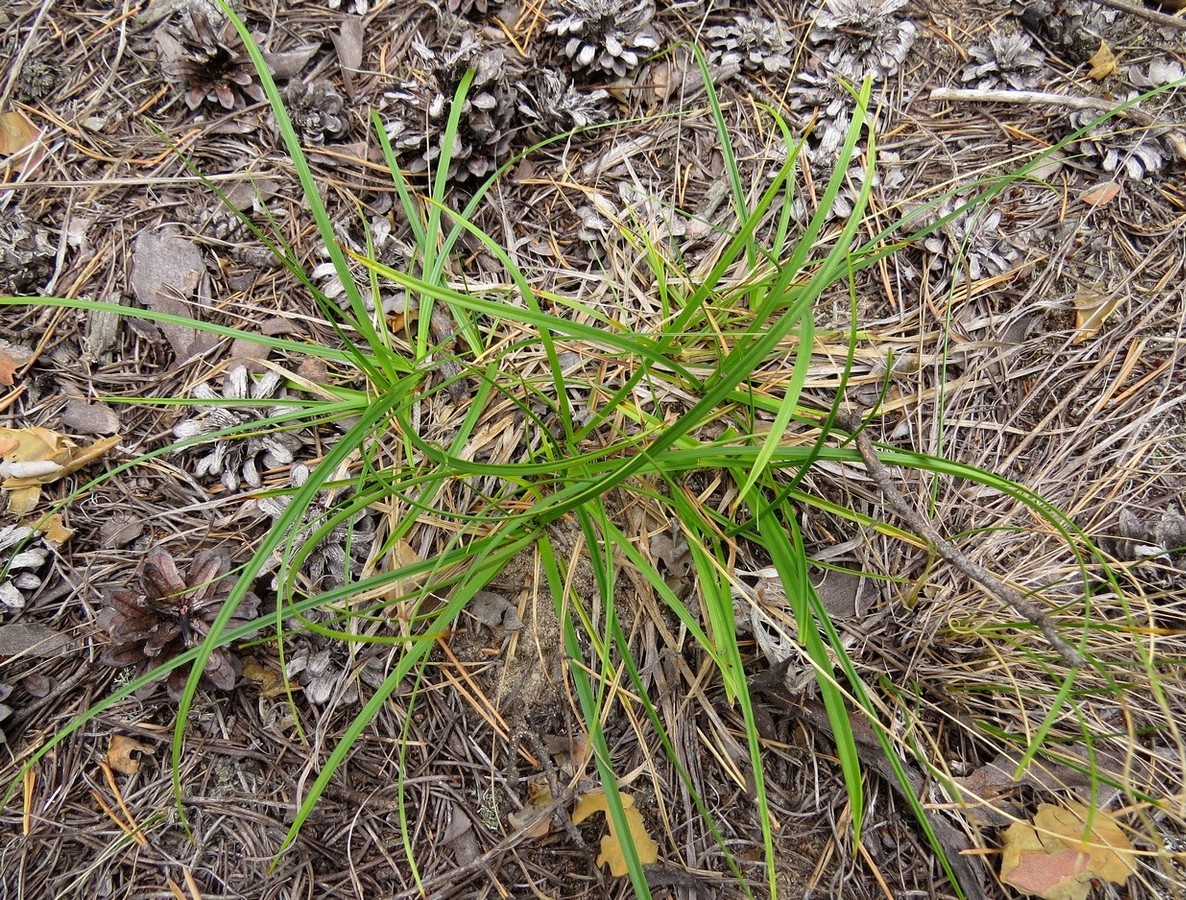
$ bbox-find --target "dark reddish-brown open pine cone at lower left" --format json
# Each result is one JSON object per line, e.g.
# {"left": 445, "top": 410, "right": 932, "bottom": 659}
{"left": 97, "top": 547, "right": 260, "bottom": 701}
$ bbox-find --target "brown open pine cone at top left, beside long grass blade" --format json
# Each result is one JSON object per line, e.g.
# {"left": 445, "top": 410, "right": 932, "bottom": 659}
{"left": 158, "top": 6, "right": 264, "bottom": 109}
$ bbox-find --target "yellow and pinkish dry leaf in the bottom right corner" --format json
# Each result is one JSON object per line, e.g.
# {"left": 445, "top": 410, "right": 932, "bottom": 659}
{"left": 1001, "top": 803, "right": 1134, "bottom": 900}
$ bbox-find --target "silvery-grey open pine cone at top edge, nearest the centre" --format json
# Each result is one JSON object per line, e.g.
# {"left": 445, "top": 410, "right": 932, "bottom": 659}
{"left": 547, "top": 0, "right": 661, "bottom": 78}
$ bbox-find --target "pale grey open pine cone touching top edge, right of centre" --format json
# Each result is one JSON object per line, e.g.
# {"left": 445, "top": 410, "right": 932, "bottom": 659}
{"left": 808, "top": 0, "right": 917, "bottom": 83}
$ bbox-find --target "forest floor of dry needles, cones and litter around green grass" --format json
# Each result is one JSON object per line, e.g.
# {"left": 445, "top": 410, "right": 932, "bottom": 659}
{"left": 0, "top": 0, "right": 1186, "bottom": 899}
